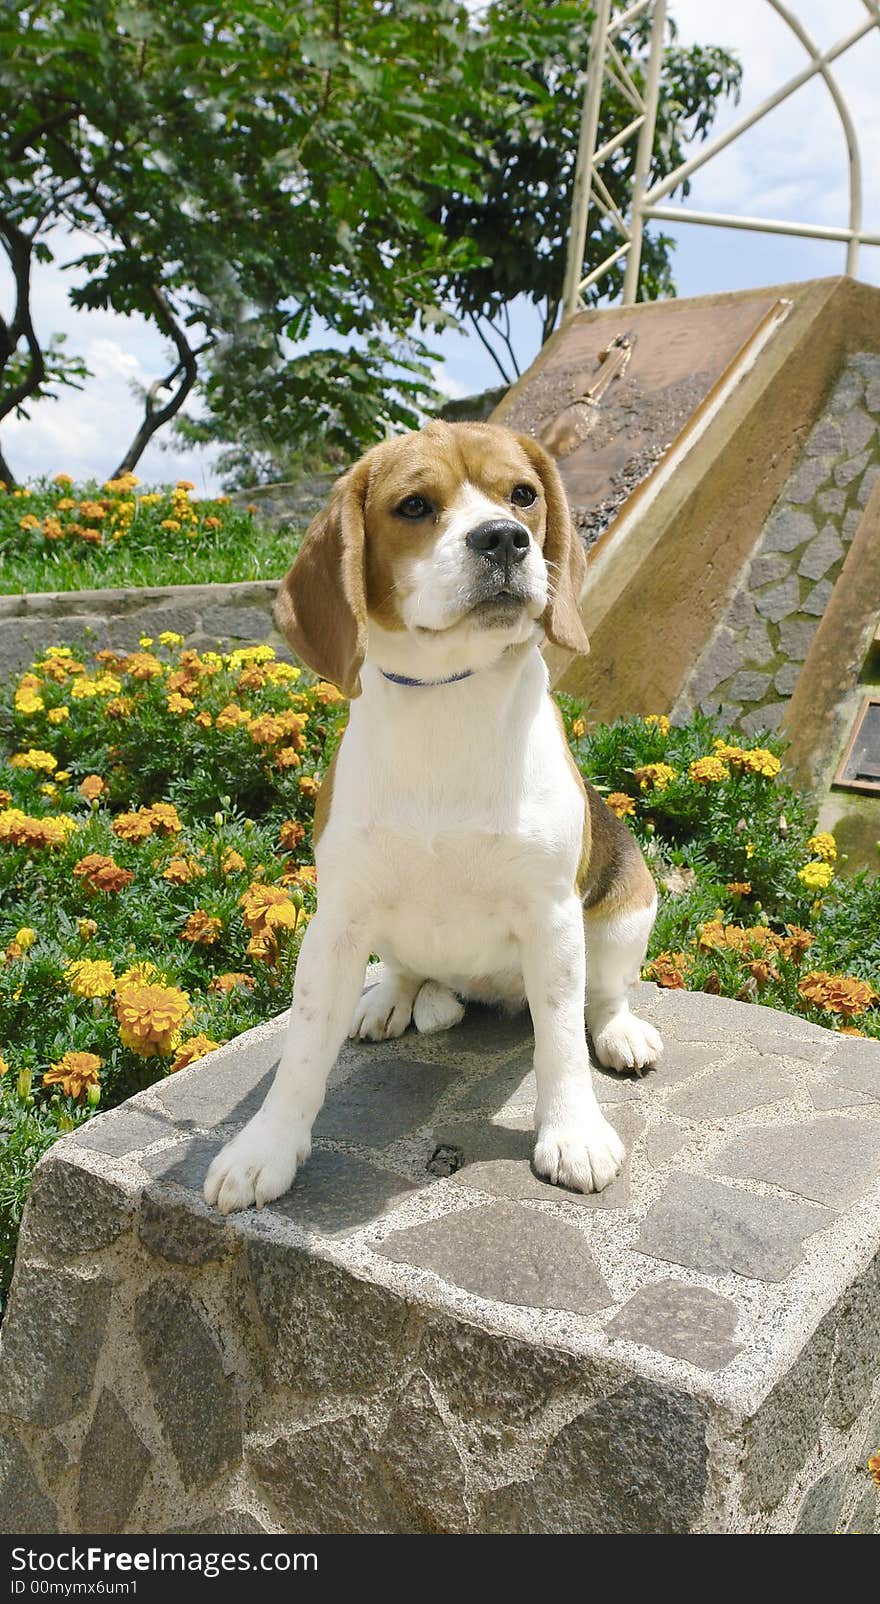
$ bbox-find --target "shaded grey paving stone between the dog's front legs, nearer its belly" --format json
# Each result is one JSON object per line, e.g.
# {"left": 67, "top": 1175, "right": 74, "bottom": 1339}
{"left": 314, "top": 1046, "right": 458, "bottom": 1147}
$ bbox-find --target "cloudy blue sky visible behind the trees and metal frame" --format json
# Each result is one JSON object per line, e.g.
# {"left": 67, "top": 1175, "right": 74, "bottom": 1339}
{"left": 0, "top": 0, "right": 880, "bottom": 491}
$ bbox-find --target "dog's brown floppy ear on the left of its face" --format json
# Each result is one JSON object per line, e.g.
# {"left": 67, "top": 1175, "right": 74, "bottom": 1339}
{"left": 276, "top": 459, "right": 369, "bottom": 696}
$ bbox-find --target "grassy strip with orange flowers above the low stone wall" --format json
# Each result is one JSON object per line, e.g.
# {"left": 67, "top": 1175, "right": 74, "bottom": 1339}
{"left": 0, "top": 480, "right": 303, "bottom": 595}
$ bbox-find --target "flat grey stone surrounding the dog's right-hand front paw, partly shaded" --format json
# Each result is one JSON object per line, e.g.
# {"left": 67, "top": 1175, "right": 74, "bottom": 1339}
{"left": 445, "top": 1105, "right": 644, "bottom": 1209}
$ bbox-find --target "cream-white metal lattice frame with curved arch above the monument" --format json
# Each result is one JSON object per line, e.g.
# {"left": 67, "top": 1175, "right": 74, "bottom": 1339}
{"left": 563, "top": 0, "right": 880, "bottom": 318}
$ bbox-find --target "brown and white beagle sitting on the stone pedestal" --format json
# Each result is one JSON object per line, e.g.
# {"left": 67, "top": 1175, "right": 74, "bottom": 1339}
{"left": 205, "top": 422, "right": 662, "bottom": 1214}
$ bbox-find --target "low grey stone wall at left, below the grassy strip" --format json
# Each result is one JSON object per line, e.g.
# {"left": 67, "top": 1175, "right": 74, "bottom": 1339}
{"left": 0, "top": 579, "right": 287, "bottom": 677}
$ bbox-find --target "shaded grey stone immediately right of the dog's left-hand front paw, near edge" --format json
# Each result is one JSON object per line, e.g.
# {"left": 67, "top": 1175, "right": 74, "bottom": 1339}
{"left": 259, "top": 1147, "right": 428, "bottom": 1237}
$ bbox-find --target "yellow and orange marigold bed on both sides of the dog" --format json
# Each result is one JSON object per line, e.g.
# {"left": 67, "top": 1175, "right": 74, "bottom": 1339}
{"left": 0, "top": 634, "right": 880, "bottom": 1315}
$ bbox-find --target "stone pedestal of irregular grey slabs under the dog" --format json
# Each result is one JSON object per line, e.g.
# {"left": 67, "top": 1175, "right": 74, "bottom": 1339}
{"left": 0, "top": 986, "right": 880, "bottom": 1533}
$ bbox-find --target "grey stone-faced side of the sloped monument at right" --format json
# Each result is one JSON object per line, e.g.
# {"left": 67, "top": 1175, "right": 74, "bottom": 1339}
{"left": 673, "top": 351, "right": 880, "bottom": 736}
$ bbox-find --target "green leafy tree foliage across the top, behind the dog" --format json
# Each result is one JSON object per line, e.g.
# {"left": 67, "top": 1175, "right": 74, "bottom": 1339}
{"left": 0, "top": 0, "right": 737, "bottom": 480}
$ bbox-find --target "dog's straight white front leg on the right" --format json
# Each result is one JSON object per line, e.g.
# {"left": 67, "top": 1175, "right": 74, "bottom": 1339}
{"left": 521, "top": 895, "right": 624, "bottom": 1192}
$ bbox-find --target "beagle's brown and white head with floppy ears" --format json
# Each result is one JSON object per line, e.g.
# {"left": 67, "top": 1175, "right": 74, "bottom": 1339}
{"left": 276, "top": 422, "right": 588, "bottom": 696}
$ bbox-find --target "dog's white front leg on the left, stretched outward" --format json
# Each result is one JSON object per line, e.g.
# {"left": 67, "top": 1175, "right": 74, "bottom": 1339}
{"left": 205, "top": 903, "right": 370, "bottom": 1214}
